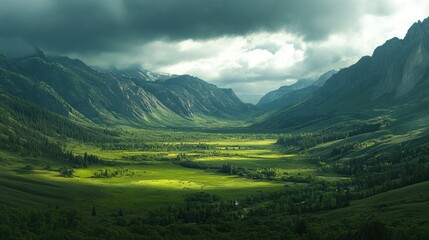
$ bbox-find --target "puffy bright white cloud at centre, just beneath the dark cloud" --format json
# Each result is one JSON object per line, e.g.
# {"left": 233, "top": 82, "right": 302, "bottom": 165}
{"left": 150, "top": 33, "right": 305, "bottom": 83}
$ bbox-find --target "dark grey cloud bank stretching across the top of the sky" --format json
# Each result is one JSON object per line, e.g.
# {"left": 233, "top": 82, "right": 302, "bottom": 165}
{"left": 0, "top": 0, "right": 389, "bottom": 53}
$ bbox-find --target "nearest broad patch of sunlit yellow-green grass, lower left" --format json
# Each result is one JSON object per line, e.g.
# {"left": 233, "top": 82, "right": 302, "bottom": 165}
{"left": 0, "top": 156, "right": 284, "bottom": 212}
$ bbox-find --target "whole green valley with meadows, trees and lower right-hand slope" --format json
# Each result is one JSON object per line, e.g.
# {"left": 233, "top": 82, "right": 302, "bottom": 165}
{"left": 0, "top": 115, "right": 429, "bottom": 239}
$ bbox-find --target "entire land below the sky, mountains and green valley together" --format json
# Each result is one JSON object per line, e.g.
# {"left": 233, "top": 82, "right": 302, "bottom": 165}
{"left": 0, "top": 15, "right": 429, "bottom": 240}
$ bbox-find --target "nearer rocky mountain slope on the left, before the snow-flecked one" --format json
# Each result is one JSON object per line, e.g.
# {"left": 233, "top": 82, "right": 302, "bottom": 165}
{"left": 0, "top": 54, "right": 174, "bottom": 122}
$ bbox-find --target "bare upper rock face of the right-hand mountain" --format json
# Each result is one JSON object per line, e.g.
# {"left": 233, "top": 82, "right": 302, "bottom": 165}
{"left": 318, "top": 19, "right": 429, "bottom": 105}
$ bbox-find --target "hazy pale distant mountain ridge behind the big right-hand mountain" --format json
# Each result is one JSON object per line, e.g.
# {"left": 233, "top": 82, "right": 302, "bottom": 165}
{"left": 256, "top": 70, "right": 337, "bottom": 111}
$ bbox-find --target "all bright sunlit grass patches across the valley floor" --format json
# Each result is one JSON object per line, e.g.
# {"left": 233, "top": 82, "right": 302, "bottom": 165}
{"left": 0, "top": 133, "right": 342, "bottom": 216}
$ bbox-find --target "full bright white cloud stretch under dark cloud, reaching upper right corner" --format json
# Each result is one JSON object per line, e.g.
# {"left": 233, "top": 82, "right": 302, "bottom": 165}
{"left": 75, "top": 0, "right": 429, "bottom": 103}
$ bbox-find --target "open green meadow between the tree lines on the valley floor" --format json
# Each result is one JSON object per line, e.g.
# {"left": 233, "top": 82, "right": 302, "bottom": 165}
{"left": 0, "top": 135, "right": 298, "bottom": 216}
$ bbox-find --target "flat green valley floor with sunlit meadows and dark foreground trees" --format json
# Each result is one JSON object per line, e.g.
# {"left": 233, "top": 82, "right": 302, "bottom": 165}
{"left": 0, "top": 126, "right": 429, "bottom": 239}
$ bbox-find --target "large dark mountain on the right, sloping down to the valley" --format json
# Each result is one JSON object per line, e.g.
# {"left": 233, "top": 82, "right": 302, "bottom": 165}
{"left": 256, "top": 19, "right": 429, "bottom": 129}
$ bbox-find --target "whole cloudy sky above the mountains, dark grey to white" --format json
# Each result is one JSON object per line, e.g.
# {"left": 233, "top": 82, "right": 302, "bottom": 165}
{"left": 0, "top": 0, "right": 429, "bottom": 103}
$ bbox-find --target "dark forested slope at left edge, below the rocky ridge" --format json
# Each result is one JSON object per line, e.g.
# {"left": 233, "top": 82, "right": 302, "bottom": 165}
{"left": 0, "top": 90, "right": 116, "bottom": 160}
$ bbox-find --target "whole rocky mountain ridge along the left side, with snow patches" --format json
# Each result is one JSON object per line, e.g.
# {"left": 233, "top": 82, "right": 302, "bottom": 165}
{"left": 0, "top": 55, "right": 254, "bottom": 126}
